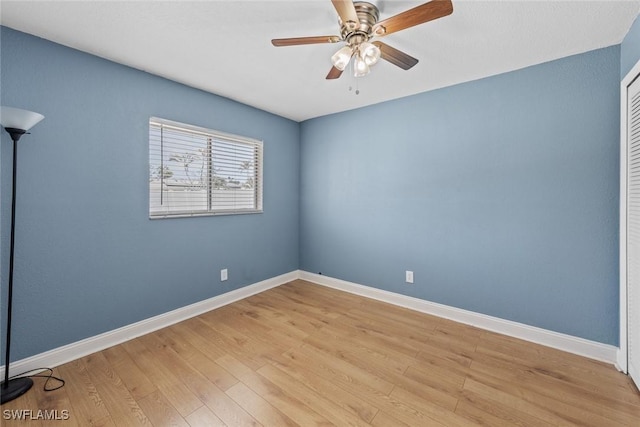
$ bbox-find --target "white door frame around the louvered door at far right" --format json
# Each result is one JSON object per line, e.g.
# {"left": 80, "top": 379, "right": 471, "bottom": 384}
{"left": 616, "top": 60, "right": 640, "bottom": 374}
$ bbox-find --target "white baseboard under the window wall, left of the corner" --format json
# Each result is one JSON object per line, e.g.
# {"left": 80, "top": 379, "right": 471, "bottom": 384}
{"left": 0, "top": 270, "right": 299, "bottom": 377}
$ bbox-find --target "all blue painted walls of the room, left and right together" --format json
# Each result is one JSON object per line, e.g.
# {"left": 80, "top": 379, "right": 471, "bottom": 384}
{"left": 0, "top": 22, "right": 640, "bottom": 360}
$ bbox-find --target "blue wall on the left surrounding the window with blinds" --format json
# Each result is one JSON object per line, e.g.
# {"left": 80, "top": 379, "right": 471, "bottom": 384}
{"left": 0, "top": 27, "right": 300, "bottom": 360}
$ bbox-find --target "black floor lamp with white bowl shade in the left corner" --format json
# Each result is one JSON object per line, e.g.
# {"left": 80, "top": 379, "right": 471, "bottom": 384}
{"left": 0, "top": 107, "right": 44, "bottom": 403}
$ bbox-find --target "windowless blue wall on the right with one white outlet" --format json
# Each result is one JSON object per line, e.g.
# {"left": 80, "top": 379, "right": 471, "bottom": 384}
{"left": 301, "top": 46, "right": 620, "bottom": 344}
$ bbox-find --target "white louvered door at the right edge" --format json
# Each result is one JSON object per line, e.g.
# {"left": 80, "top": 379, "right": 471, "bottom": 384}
{"left": 626, "top": 77, "right": 640, "bottom": 387}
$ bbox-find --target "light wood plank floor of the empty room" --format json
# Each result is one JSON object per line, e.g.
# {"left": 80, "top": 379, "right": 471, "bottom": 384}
{"left": 0, "top": 281, "right": 640, "bottom": 427}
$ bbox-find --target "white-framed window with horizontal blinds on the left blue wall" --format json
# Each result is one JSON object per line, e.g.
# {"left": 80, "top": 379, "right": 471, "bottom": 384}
{"left": 149, "top": 117, "right": 262, "bottom": 218}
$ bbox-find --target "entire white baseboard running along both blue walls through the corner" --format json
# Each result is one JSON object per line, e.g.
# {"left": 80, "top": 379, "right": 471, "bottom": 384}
{"left": 0, "top": 270, "right": 619, "bottom": 377}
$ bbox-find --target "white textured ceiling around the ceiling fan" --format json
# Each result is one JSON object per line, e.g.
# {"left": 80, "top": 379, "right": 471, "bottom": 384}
{"left": 0, "top": 0, "right": 640, "bottom": 121}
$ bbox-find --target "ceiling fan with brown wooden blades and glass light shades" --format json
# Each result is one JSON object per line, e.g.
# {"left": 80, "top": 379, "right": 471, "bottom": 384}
{"left": 271, "top": 0, "right": 453, "bottom": 80}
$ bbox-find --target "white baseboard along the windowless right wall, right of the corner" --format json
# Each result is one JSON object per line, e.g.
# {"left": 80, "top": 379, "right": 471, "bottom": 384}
{"left": 300, "top": 271, "right": 618, "bottom": 365}
